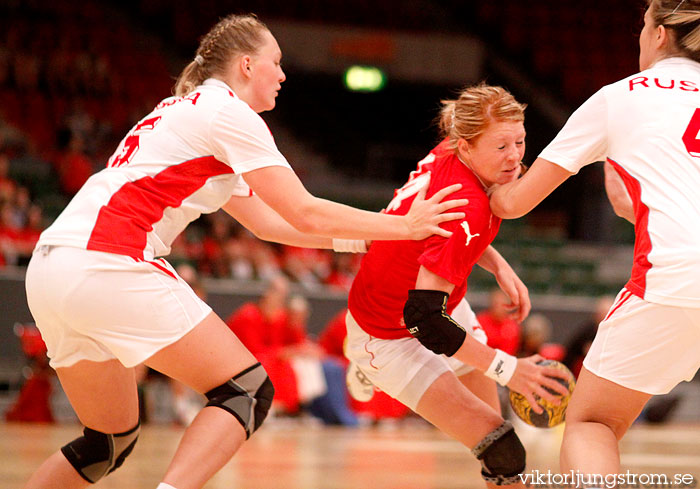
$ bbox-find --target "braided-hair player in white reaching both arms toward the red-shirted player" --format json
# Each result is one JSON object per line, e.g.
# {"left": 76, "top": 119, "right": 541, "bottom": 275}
{"left": 26, "top": 15, "right": 466, "bottom": 489}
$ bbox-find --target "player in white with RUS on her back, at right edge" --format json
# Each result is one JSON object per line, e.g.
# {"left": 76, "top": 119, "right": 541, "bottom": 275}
{"left": 491, "top": 0, "right": 700, "bottom": 478}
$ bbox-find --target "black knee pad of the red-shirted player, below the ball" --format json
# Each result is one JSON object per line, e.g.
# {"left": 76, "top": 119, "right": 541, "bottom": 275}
{"left": 472, "top": 421, "right": 525, "bottom": 486}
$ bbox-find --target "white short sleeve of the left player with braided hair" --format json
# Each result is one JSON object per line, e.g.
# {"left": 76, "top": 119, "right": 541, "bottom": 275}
{"left": 209, "top": 100, "right": 291, "bottom": 174}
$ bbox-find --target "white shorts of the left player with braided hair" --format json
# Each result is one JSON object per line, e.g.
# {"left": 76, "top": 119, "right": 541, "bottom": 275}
{"left": 25, "top": 246, "right": 211, "bottom": 368}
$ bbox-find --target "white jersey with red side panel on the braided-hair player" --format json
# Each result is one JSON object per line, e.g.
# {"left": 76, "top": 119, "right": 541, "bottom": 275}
{"left": 37, "top": 79, "right": 289, "bottom": 260}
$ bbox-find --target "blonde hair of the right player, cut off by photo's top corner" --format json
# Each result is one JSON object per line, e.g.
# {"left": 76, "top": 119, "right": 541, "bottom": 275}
{"left": 649, "top": 0, "right": 700, "bottom": 62}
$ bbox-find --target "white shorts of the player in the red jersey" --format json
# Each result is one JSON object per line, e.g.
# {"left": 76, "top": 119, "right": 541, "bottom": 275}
{"left": 345, "top": 299, "right": 487, "bottom": 411}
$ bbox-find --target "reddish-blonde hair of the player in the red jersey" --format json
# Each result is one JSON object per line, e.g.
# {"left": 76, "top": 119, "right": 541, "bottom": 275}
{"left": 438, "top": 83, "right": 526, "bottom": 150}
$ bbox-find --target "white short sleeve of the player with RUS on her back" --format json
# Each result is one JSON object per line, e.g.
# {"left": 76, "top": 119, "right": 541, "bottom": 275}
{"left": 540, "top": 90, "right": 608, "bottom": 173}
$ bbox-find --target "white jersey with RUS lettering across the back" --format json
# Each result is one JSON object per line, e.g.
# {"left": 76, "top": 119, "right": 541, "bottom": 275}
{"left": 540, "top": 58, "right": 700, "bottom": 307}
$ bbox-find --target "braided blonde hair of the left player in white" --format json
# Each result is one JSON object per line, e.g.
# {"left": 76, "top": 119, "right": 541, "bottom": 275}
{"left": 173, "top": 14, "right": 269, "bottom": 97}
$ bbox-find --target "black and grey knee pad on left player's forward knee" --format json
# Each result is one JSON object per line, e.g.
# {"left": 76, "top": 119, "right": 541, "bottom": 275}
{"left": 206, "top": 363, "right": 275, "bottom": 439}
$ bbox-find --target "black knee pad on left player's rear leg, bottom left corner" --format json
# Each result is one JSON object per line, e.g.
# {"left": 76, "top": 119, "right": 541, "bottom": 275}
{"left": 61, "top": 423, "right": 141, "bottom": 484}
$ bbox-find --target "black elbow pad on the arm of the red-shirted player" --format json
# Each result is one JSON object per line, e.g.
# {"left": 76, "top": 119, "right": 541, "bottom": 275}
{"left": 403, "top": 290, "right": 467, "bottom": 357}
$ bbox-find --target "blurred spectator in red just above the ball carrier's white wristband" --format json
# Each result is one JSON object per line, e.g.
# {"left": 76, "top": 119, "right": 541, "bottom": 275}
{"left": 476, "top": 288, "right": 520, "bottom": 355}
